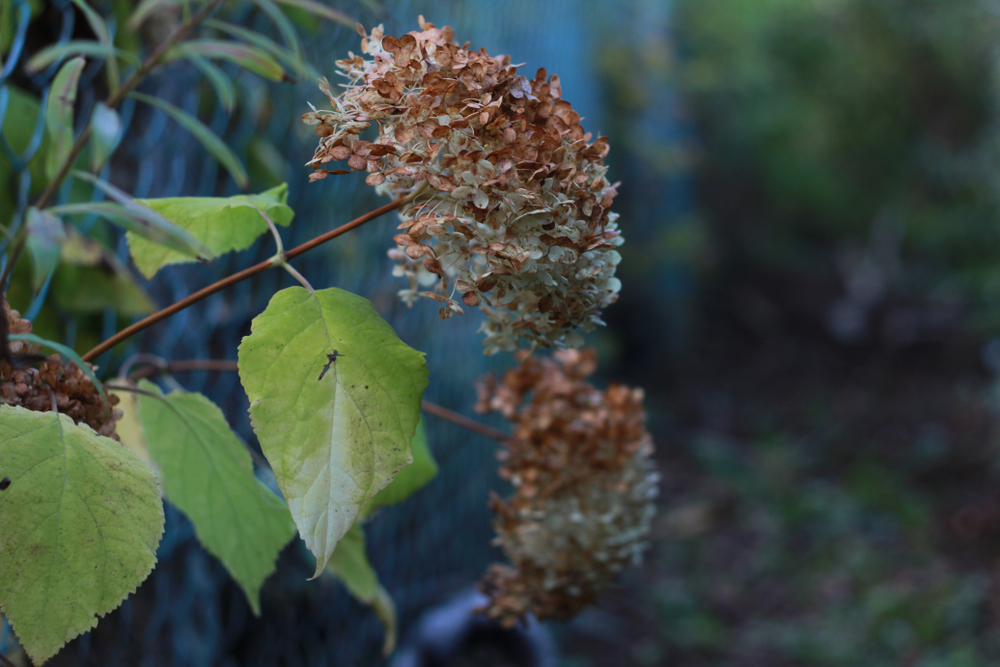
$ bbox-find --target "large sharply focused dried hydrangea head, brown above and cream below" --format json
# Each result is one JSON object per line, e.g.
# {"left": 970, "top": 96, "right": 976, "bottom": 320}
{"left": 303, "top": 17, "right": 622, "bottom": 354}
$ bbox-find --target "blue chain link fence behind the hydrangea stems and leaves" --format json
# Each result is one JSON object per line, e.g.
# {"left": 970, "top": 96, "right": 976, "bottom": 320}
{"left": 0, "top": 0, "right": 672, "bottom": 667}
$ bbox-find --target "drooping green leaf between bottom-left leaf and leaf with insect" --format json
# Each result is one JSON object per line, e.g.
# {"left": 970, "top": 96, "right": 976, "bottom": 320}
{"left": 139, "top": 381, "right": 295, "bottom": 615}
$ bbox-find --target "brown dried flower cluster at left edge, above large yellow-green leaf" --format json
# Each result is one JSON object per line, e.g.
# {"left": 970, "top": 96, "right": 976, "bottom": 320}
{"left": 0, "top": 300, "right": 121, "bottom": 440}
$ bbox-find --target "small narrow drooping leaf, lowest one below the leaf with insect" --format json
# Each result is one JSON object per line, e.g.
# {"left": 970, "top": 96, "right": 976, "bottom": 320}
{"left": 327, "top": 524, "right": 396, "bottom": 656}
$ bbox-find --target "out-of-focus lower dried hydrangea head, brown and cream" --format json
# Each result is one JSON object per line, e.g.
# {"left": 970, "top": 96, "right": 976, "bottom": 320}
{"left": 477, "top": 350, "right": 659, "bottom": 625}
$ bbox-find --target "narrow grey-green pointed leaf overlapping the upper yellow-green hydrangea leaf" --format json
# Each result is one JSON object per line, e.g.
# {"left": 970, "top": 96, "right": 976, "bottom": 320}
{"left": 62, "top": 171, "right": 215, "bottom": 262}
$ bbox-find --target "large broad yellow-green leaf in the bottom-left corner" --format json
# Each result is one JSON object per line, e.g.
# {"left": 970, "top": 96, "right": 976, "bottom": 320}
{"left": 0, "top": 405, "right": 163, "bottom": 664}
